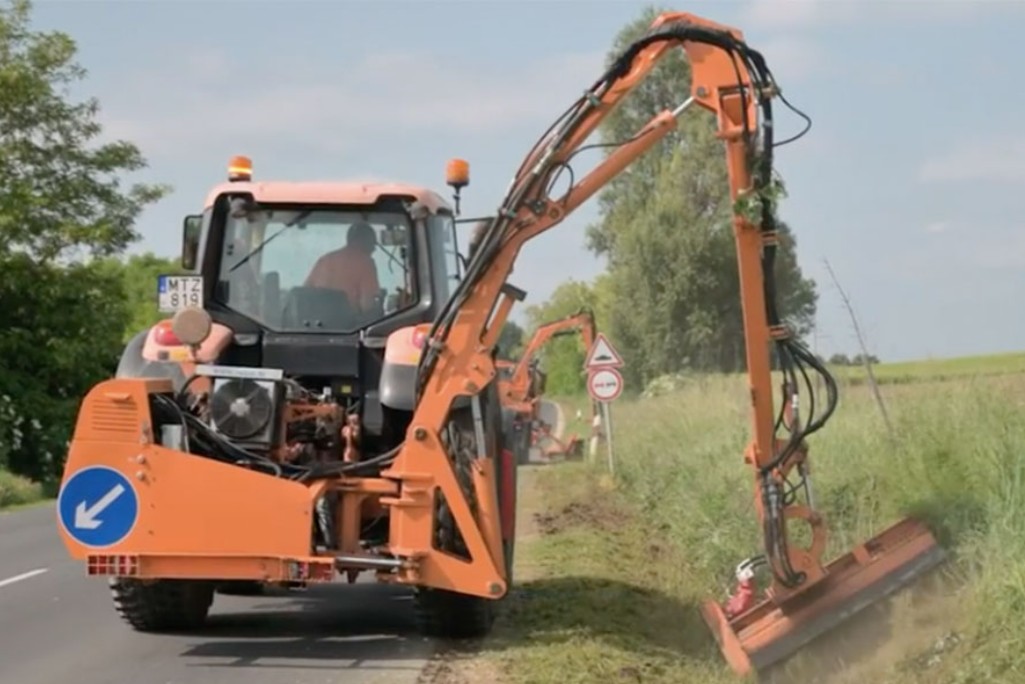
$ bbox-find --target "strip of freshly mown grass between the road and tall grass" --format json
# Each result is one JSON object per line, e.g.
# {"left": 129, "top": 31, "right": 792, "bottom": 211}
{"left": 434, "top": 462, "right": 727, "bottom": 684}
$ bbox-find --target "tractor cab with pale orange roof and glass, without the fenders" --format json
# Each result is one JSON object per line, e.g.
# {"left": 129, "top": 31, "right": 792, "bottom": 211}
{"left": 178, "top": 157, "right": 460, "bottom": 338}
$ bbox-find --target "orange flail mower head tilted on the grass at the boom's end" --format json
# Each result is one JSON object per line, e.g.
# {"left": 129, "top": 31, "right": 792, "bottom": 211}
{"left": 701, "top": 518, "right": 945, "bottom": 675}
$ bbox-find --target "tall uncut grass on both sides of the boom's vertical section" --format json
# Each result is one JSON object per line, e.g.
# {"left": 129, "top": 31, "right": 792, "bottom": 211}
{"left": 614, "top": 374, "right": 1025, "bottom": 682}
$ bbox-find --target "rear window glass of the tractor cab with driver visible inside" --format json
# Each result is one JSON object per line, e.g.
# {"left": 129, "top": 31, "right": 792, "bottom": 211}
{"left": 216, "top": 201, "right": 417, "bottom": 332}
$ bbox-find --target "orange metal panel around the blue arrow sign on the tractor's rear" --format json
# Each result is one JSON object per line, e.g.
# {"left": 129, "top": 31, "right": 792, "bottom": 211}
{"left": 57, "top": 426, "right": 333, "bottom": 580}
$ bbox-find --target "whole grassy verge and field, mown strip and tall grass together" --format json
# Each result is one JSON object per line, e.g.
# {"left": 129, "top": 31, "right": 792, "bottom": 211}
{"left": 463, "top": 355, "right": 1025, "bottom": 684}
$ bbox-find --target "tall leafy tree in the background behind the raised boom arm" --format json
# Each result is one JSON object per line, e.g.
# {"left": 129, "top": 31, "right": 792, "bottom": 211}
{"left": 587, "top": 7, "right": 817, "bottom": 384}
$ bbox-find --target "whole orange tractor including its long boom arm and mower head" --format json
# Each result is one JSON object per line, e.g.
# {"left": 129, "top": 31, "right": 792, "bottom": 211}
{"left": 57, "top": 12, "right": 943, "bottom": 673}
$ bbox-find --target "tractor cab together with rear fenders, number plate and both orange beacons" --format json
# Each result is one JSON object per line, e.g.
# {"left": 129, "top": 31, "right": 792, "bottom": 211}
{"left": 117, "top": 156, "right": 468, "bottom": 448}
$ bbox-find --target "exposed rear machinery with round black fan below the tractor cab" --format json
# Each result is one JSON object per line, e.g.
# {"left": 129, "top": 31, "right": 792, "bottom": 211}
{"left": 151, "top": 364, "right": 401, "bottom": 553}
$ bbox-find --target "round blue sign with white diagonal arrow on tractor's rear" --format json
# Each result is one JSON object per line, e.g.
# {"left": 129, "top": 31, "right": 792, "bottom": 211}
{"left": 57, "top": 466, "right": 138, "bottom": 549}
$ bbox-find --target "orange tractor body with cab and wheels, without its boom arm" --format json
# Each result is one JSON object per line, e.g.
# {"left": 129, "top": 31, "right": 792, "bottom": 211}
{"left": 58, "top": 157, "right": 522, "bottom": 636}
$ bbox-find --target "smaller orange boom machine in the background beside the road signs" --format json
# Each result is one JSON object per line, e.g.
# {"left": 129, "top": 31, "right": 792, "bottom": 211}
{"left": 498, "top": 309, "right": 598, "bottom": 462}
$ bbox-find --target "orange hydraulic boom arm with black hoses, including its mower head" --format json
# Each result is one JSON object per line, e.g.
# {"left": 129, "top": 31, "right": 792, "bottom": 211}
{"left": 383, "top": 12, "right": 934, "bottom": 672}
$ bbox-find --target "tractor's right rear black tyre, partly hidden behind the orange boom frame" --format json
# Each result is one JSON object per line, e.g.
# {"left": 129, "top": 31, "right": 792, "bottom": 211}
{"left": 414, "top": 384, "right": 516, "bottom": 639}
